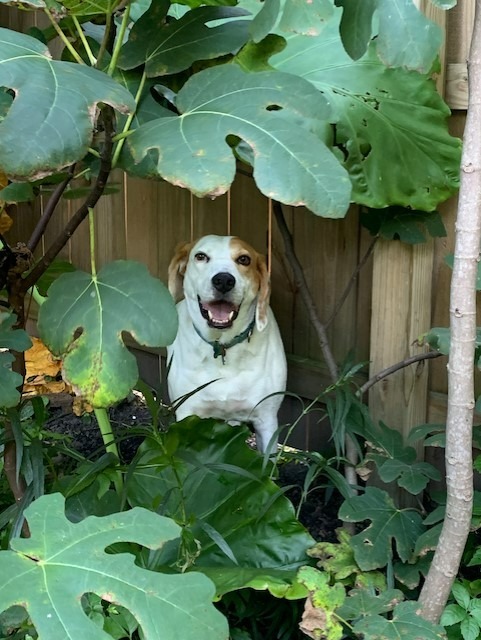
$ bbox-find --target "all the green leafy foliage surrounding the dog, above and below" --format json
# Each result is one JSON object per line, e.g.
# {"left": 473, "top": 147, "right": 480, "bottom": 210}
{"left": 0, "top": 0, "right": 466, "bottom": 640}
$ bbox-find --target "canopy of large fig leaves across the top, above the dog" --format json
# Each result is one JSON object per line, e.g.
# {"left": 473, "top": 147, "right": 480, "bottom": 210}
{"left": 0, "top": 0, "right": 459, "bottom": 217}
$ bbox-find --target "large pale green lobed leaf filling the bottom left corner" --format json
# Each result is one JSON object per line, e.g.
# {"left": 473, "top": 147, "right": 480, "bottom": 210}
{"left": 0, "top": 494, "right": 228, "bottom": 640}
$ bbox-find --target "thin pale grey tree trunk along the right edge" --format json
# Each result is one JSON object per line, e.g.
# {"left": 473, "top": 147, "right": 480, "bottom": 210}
{"left": 419, "top": 0, "right": 481, "bottom": 622}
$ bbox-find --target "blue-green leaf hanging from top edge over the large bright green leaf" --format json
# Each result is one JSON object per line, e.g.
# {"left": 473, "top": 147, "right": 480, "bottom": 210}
{"left": 338, "top": 0, "right": 443, "bottom": 73}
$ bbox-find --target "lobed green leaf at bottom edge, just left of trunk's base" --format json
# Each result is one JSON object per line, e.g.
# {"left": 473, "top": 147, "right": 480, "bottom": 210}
{"left": 353, "top": 602, "right": 446, "bottom": 640}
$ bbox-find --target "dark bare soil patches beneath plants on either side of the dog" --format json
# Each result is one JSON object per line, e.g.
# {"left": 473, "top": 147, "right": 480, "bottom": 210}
{"left": 45, "top": 396, "right": 342, "bottom": 542}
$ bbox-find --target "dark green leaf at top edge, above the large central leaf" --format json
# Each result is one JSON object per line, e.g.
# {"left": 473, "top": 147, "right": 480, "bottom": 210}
{"left": 119, "top": 2, "right": 250, "bottom": 77}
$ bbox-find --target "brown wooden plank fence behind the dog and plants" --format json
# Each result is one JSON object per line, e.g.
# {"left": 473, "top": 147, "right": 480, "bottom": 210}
{"left": 0, "top": 0, "right": 474, "bottom": 447}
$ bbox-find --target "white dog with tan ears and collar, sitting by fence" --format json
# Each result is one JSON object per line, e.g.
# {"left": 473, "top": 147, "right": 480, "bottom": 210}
{"left": 167, "top": 235, "right": 287, "bottom": 452}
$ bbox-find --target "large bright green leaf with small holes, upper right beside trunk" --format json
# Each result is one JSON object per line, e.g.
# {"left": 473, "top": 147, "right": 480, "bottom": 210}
{"left": 271, "top": 19, "right": 461, "bottom": 211}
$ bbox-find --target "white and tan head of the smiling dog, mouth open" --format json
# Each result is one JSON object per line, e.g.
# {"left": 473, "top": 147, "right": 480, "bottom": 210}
{"left": 169, "top": 235, "right": 270, "bottom": 331}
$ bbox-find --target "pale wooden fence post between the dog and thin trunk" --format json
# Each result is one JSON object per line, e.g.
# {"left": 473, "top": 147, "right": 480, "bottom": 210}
{"left": 369, "top": 0, "right": 446, "bottom": 476}
